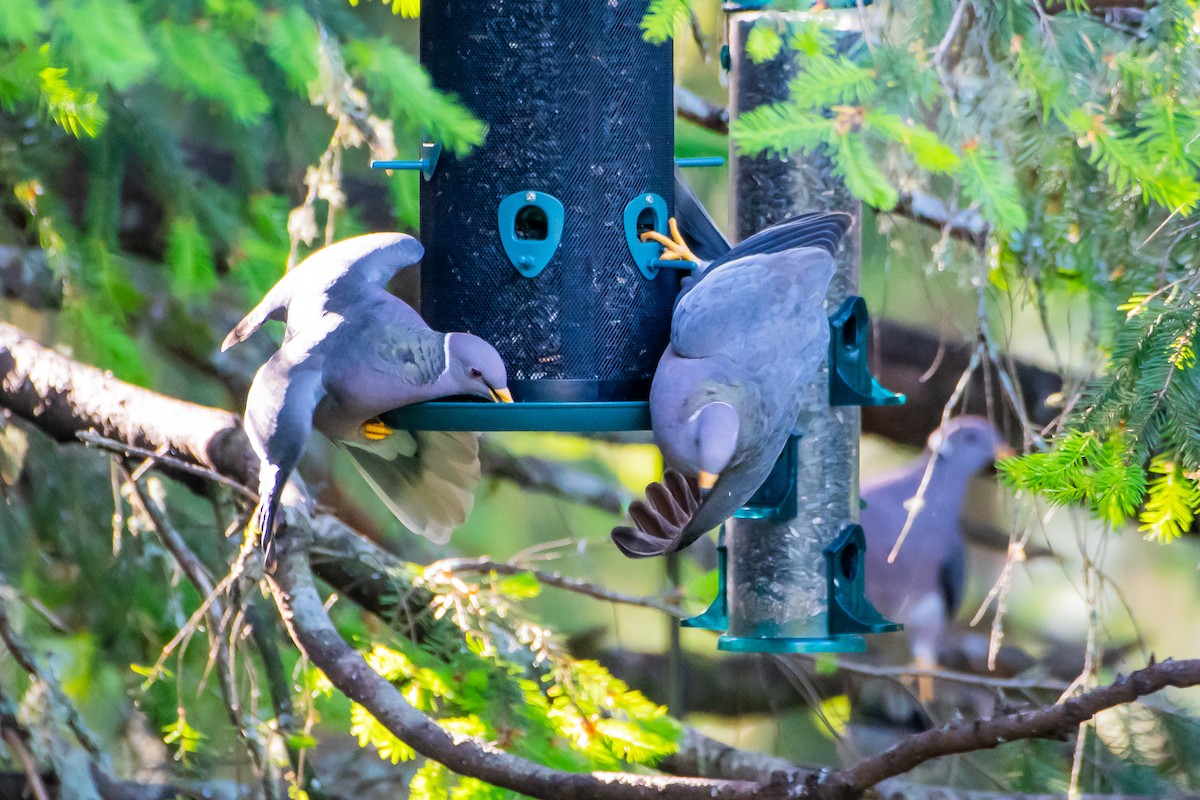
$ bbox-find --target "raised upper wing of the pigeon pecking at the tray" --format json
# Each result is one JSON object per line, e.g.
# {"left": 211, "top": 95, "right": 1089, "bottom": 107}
{"left": 221, "top": 233, "right": 425, "bottom": 351}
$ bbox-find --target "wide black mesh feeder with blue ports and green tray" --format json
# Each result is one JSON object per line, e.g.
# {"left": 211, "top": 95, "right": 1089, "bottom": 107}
{"left": 374, "top": 0, "right": 696, "bottom": 431}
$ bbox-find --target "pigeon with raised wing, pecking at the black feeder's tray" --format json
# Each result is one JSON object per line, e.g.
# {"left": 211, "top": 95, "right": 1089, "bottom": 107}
{"left": 221, "top": 234, "right": 512, "bottom": 565}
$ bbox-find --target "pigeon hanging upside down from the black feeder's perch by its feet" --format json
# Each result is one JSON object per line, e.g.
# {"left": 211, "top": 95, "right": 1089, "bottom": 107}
{"left": 612, "top": 197, "right": 851, "bottom": 558}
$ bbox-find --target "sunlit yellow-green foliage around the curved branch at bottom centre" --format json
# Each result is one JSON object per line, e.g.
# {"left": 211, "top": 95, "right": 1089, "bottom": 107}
{"left": 333, "top": 567, "right": 680, "bottom": 798}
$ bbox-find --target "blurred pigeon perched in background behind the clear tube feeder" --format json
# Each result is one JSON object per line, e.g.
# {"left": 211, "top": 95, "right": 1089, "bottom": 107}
{"left": 859, "top": 416, "right": 1013, "bottom": 699}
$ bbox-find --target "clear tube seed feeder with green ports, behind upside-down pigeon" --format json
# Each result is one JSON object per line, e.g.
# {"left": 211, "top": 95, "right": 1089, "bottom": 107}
{"left": 684, "top": 2, "right": 904, "bottom": 652}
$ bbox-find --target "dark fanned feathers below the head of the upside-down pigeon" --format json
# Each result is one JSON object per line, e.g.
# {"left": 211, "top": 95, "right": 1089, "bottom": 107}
{"left": 612, "top": 469, "right": 701, "bottom": 559}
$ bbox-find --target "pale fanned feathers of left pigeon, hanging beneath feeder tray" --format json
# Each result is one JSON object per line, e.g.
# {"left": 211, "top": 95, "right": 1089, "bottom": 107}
{"left": 343, "top": 431, "right": 479, "bottom": 545}
